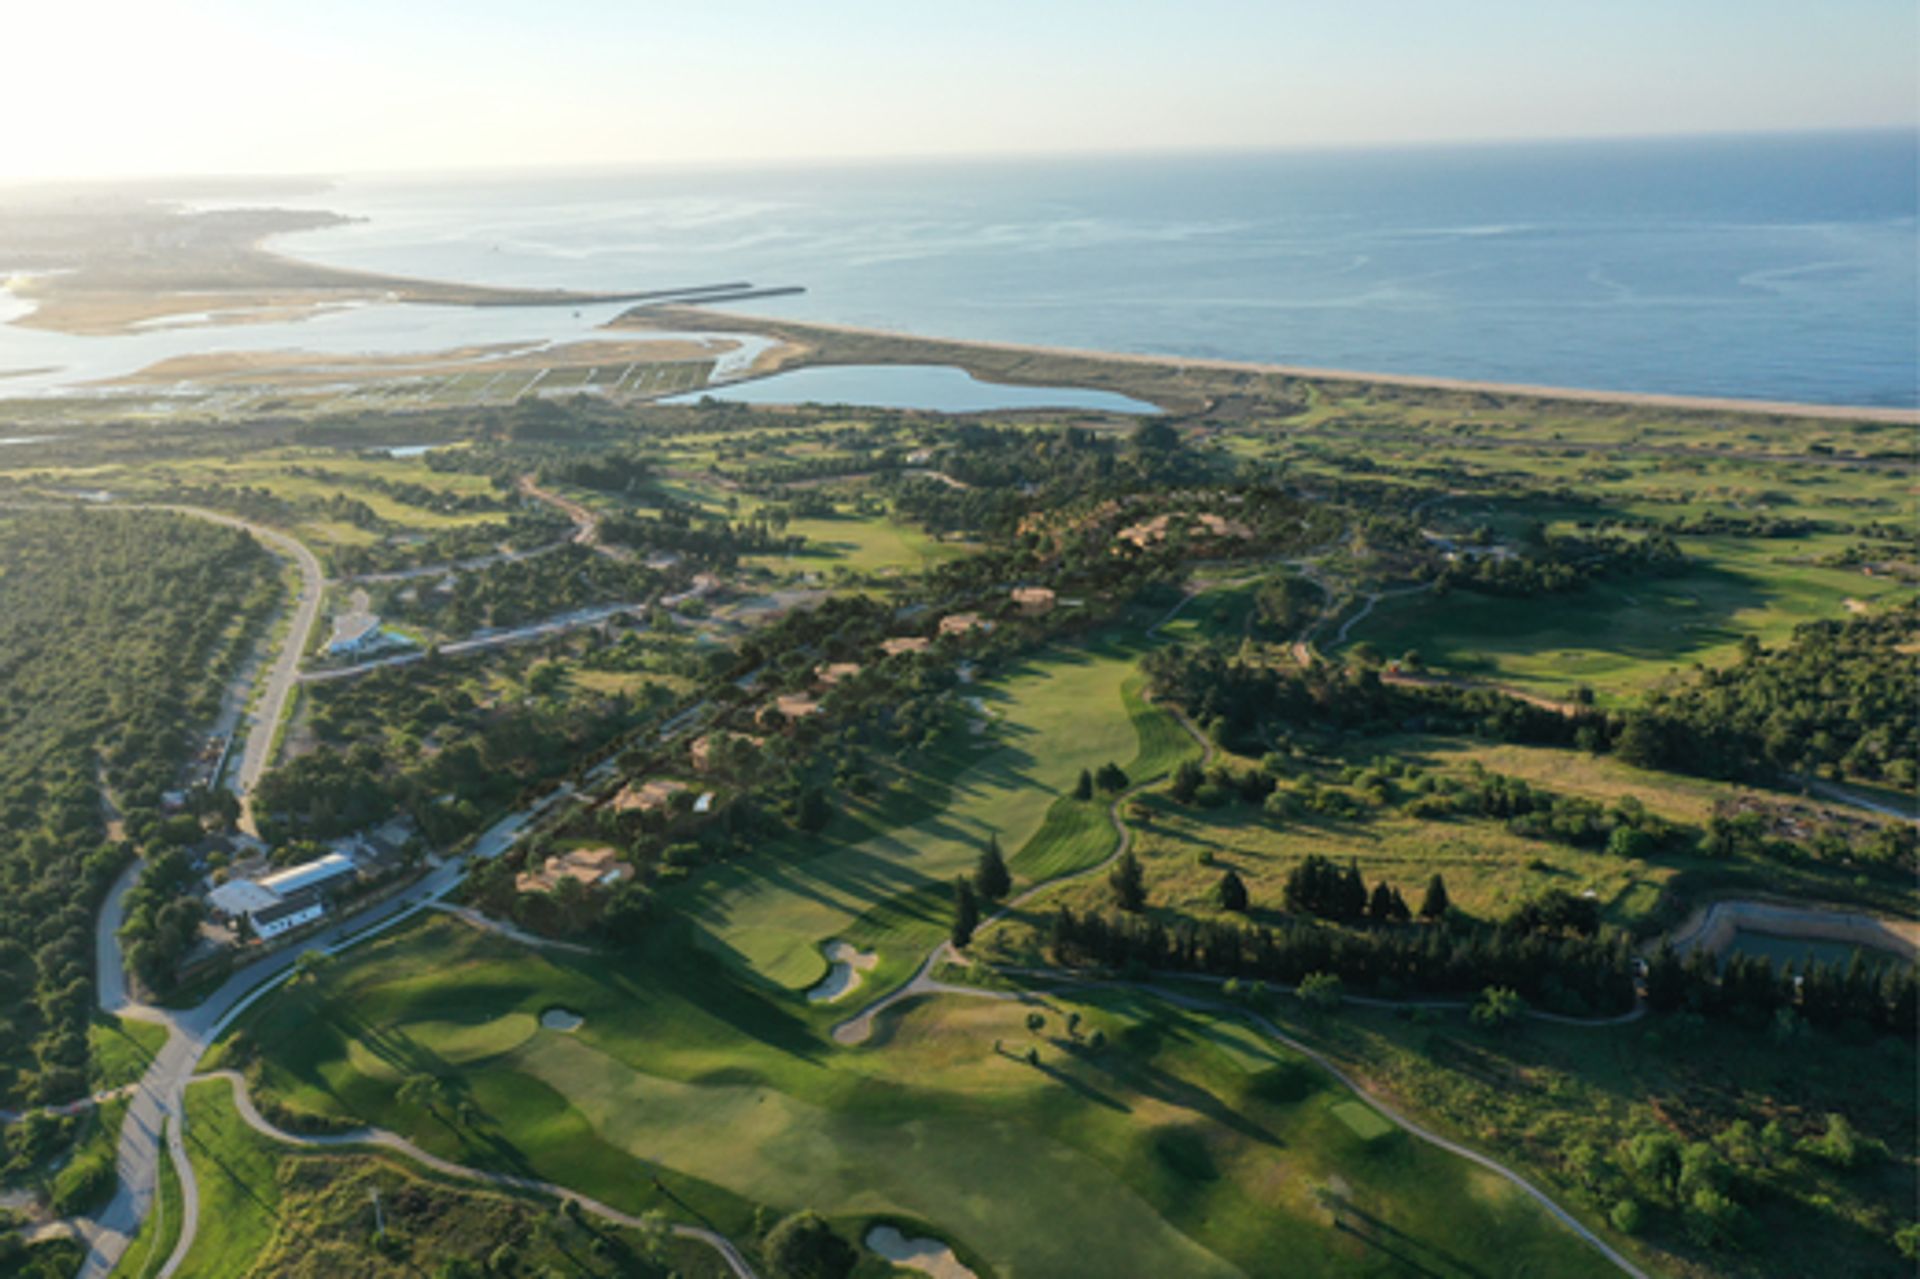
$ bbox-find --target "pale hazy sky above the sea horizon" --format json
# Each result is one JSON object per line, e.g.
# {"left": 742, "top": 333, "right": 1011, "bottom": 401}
{"left": 0, "top": 0, "right": 1920, "bottom": 179}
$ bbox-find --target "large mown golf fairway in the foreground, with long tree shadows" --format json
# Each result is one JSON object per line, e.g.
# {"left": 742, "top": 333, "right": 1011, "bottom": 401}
{"left": 206, "top": 920, "right": 1607, "bottom": 1275}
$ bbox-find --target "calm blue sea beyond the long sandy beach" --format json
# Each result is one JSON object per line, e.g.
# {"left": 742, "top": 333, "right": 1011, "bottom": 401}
{"left": 275, "top": 133, "right": 1920, "bottom": 405}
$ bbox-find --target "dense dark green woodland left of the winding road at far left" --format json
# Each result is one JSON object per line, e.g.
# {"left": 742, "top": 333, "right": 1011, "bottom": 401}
{"left": 0, "top": 509, "right": 280, "bottom": 1106}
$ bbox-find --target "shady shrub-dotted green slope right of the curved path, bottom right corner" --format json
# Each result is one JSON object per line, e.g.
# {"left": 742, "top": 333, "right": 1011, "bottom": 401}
{"left": 1221, "top": 979, "right": 1916, "bottom": 1279}
